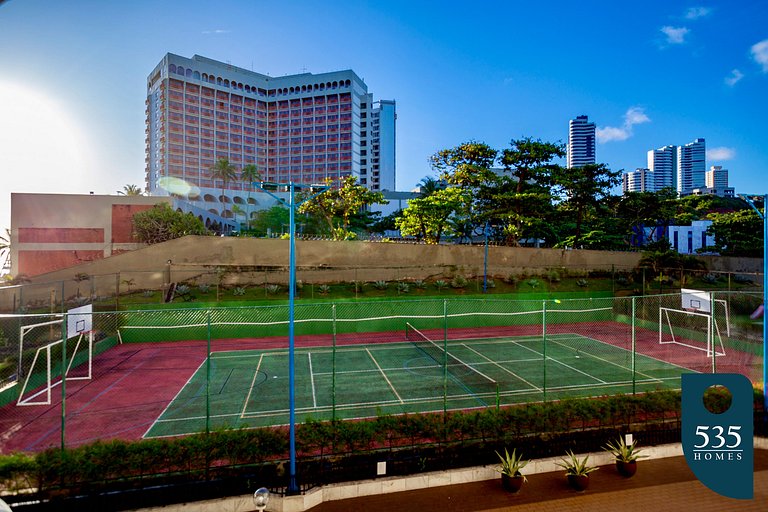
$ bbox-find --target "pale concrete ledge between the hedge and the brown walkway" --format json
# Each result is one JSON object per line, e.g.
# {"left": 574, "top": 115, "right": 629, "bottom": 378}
{"left": 130, "top": 437, "right": 768, "bottom": 512}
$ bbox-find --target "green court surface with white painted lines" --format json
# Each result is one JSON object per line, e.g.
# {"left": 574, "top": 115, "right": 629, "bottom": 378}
{"left": 145, "top": 334, "right": 690, "bottom": 437}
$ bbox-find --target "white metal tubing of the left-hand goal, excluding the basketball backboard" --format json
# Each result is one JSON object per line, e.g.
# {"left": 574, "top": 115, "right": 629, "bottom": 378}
{"left": 16, "top": 320, "right": 93, "bottom": 406}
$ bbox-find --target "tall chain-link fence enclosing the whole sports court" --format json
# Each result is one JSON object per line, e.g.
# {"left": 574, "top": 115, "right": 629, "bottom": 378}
{"left": 0, "top": 288, "right": 763, "bottom": 453}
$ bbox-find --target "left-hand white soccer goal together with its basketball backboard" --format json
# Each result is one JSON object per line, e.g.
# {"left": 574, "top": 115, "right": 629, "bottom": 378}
{"left": 16, "top": 305, "right": 93, "bottom": 406}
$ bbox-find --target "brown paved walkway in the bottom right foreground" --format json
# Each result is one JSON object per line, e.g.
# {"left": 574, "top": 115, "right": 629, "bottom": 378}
{"left": 310, "top": 450, "right": 768, "bottom": 512}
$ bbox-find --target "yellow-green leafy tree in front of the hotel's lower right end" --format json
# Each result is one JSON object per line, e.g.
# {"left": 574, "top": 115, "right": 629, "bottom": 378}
{"left": 299, "top": 176, "right": 388, "bottom": 240}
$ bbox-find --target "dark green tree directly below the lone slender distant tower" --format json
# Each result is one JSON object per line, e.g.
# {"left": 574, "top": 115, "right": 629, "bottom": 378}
{"left": 552, "top": 164, "right": 621, "bottom": 247}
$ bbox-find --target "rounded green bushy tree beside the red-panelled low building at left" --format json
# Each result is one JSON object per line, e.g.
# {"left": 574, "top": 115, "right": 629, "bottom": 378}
{"left": 133, "top": 203, "right": 208, "bottom": 244}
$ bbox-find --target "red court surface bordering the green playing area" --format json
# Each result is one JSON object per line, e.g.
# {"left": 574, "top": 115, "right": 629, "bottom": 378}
{"left": 0, "top": 322, "right": 760, "bottom": 454}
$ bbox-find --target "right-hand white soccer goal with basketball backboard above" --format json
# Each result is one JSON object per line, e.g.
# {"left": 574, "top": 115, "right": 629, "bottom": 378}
{"left": 659, "top": 289, "right": 731, "bottom": 357}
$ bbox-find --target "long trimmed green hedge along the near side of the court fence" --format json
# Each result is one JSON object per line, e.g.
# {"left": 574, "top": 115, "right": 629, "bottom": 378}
{"left": 0, "top": 390, "right": 762, "bottom": 504}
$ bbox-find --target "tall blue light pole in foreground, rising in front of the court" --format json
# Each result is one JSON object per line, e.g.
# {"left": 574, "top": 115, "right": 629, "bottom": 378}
{"left": 254, "top": 181, "right": 329, "bottom": 494}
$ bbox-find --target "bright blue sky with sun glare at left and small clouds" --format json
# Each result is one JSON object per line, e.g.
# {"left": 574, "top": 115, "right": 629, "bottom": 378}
{"left": 0, "top": 0, "right": 768, "bottom": 233}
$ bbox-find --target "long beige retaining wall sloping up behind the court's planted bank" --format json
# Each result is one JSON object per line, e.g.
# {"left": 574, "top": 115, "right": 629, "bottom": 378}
{"left": 12, "top": 236, "right": 762, "bottom": 293}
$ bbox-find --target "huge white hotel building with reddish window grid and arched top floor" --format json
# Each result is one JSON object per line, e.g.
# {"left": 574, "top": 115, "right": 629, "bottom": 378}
{"left": 146, "top": 53, "right": 396, "bottom": 218}
